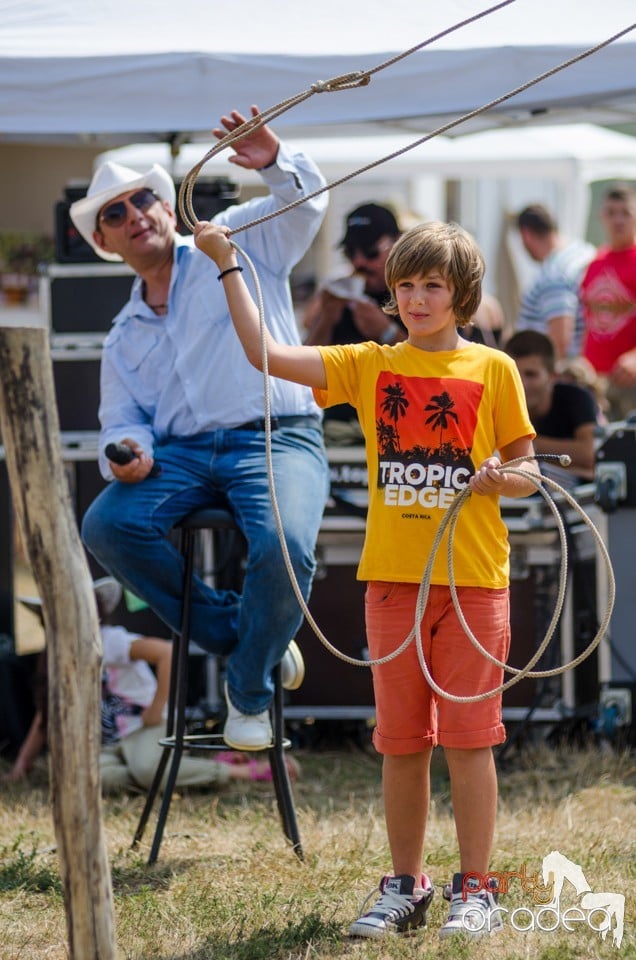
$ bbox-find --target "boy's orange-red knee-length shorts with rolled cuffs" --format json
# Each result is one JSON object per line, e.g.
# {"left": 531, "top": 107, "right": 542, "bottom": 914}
{"left": 365, "top": 581, "right": 510, "bottom": 754}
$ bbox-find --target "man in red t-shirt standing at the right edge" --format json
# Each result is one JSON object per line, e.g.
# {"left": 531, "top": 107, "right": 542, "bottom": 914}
{"left": 581, "top": 184, "right": 636, "bottom": 420}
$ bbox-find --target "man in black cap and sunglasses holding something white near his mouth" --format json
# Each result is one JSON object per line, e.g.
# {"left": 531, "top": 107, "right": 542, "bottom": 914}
{"left": 304, "top": 203, "right": 406, "bottom": 443}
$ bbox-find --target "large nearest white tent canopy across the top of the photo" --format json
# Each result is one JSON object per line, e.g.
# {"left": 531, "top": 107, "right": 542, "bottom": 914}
{"left": 0, "top": 0, "right": 636, "bottom": 145}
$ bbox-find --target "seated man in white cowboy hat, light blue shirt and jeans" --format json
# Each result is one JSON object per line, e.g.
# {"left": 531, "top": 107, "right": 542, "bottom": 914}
{"left": 70, "top": 107, "right": 328, "bottom": 750}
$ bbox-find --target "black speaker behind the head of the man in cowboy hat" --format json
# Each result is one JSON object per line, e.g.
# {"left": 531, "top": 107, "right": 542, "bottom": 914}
{"left": 54, "top": 177, "right": 239, "bottom": 263}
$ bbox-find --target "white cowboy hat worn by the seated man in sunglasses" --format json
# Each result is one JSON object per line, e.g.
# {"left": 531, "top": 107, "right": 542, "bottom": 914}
{"left": 69, "top": 160, "right": 175, "bottom": 262}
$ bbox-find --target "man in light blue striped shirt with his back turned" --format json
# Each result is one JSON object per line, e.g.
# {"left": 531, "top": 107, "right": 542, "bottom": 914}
{"left": 516, "top": 203, "right": 594, "bottom": 360}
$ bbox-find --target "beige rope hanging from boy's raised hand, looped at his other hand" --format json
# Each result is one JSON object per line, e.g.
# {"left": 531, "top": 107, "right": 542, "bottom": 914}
{"left": 232, "top": 241, "right": 616, "bottom": 703}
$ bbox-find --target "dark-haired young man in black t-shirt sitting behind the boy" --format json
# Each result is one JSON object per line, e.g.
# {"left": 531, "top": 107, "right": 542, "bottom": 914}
{"left": 504, "top": 330, "right": 599, "bottom": 483}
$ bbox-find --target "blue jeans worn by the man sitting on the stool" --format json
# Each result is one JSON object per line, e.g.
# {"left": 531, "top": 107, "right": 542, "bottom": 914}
{"left": 82, "top": 427, "right": 329, "bottom": 714}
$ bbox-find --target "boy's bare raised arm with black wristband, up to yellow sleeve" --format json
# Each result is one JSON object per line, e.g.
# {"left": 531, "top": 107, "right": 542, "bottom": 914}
{"left": 194, "top": 221, "right": 327, "bottom": 390}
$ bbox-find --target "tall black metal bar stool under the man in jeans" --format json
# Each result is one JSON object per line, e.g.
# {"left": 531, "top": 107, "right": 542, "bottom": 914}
{"left": 132, "top": 508, "right": 304, "bottom": 864}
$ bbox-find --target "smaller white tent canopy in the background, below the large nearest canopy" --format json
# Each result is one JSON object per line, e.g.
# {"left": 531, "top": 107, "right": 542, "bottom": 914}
{"left": 96, "top": 123, "right": 636, "bottom": 296}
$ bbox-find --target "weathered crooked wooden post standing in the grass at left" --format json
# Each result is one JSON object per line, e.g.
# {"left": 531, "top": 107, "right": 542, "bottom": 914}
{"left": 0, "top": 327, "right": 116, "bottom": 960}
